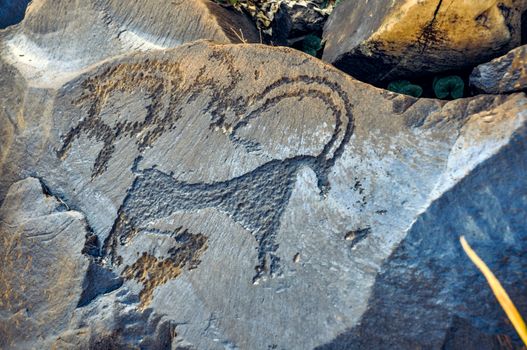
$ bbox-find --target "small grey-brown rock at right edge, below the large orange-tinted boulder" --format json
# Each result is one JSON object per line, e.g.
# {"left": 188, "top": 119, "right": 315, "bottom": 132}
{"left": 470, "top": 45, "right": 527, "bottom": 94}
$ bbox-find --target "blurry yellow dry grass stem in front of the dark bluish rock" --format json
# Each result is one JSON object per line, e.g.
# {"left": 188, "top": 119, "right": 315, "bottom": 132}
{"left": 459, "top": 236, "right": 527, "bottom": 345}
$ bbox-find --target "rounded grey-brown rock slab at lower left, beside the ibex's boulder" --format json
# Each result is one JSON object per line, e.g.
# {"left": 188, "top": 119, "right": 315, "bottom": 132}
{"left": 0, "top": 178, "right": 88, "bottom": 349}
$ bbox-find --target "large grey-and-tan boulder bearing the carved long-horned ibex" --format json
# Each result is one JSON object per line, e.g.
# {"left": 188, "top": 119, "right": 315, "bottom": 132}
{"left": 0, "top": 37, "right": 527, "bottom": 349}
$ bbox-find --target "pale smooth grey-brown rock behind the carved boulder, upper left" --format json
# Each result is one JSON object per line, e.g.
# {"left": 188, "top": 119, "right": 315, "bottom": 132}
{"left": 0, "top": 0, "right": 259, "bottom": 87}
